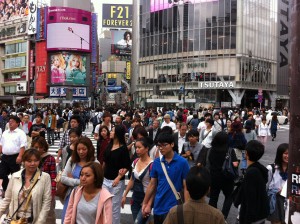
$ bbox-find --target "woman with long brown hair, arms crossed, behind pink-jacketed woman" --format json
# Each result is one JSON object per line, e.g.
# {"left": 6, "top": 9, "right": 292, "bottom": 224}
{"left": 61, "top": 137, "right": 95, "bottom": 223}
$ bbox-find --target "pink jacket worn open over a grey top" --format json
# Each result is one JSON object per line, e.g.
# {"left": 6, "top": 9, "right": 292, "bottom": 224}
{"left": 64, "top": 187, "right": 113, "bottom": 224}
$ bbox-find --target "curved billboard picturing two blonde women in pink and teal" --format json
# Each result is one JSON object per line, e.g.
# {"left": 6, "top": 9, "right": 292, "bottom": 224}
{"left": 50, "top": 52, "right": 87, "bottom": 85}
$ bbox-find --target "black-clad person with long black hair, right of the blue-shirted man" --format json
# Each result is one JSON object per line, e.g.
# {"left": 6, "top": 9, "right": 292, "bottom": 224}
{"left": 208, "top": 132, "right": 238, "bottom": 219}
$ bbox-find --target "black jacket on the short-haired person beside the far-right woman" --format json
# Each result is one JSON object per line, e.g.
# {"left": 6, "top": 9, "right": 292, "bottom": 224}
{"left": 239, "top": 162, "right": 270, "bottom": 224}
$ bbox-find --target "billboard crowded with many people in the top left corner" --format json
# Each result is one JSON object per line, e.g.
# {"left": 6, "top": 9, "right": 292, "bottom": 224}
{"left": 0, "top": 0, "right": 29, "bottom": 23}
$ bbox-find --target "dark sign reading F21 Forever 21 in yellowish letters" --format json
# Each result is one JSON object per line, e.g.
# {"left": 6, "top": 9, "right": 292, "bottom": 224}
{"left": 102, "top": 4, "right": 132, "bottom": 28}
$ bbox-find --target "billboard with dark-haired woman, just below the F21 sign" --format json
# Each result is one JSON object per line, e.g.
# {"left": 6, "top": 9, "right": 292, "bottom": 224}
{"left": 111, "top": 30, "right": 132, "bottom": 55}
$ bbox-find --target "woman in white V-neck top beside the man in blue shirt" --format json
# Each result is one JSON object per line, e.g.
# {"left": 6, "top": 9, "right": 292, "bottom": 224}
{"left": 121, "top": 138, "right": 153, "bottom": 224}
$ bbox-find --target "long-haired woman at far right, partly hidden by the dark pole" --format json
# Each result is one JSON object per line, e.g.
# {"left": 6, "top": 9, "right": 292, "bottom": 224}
{"left": 267, "top": 143, "right": 289, "bottom": 224}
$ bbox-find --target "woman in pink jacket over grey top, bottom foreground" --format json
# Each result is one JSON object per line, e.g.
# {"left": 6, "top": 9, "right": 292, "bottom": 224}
{"left": 65, "top": 162, "right": 113, "bottom": 224}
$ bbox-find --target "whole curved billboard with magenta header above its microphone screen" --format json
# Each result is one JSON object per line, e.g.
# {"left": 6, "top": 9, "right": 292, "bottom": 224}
{"left": 47, "top": 7, "right": 91, "bottom": 52}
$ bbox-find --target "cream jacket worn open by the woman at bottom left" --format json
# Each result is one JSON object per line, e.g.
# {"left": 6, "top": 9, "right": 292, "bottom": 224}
{"left": 0, "top": 170, "right": 52, "bottom": 224}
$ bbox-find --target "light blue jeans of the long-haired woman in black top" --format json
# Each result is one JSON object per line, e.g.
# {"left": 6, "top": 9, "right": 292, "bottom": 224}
{"left": 103, "top": 178, "right": 125, "bottom": 224}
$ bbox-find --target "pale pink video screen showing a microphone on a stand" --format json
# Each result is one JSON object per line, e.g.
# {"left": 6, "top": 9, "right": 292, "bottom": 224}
{"left": 47, "top": 23, "right": 90, "bottom": 52}
